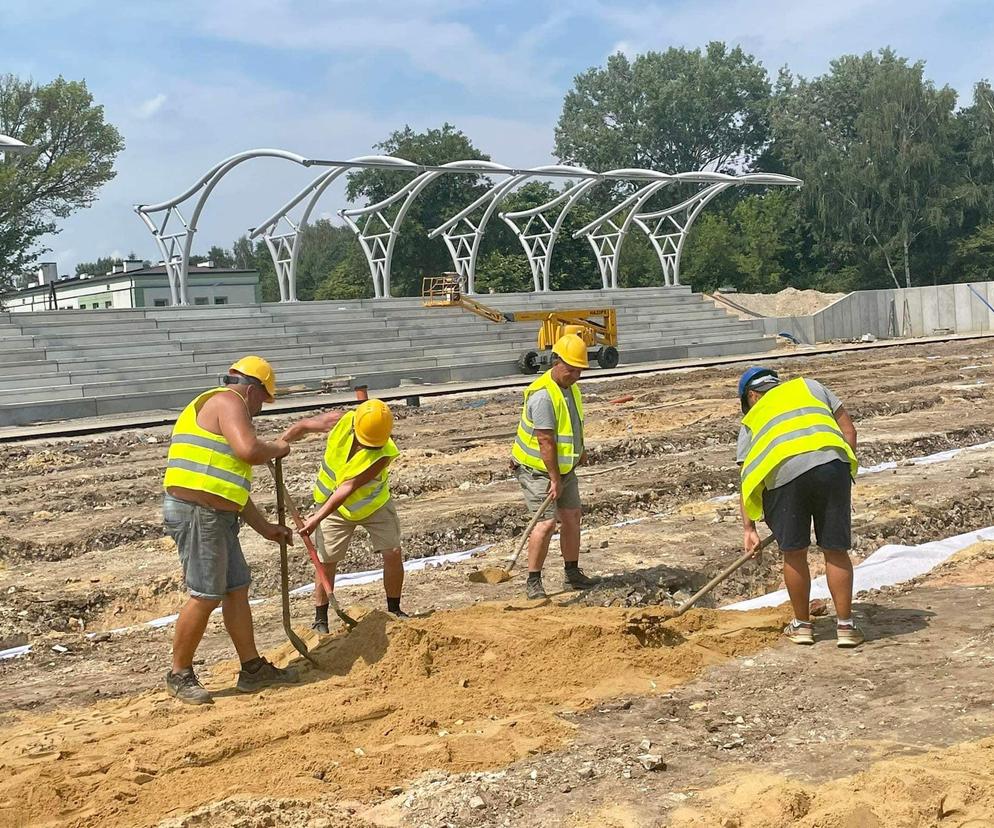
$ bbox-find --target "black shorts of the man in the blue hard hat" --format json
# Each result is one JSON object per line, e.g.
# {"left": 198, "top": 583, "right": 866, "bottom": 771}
{"left": 763, "top": 460, "right": 852, "bottom": 551}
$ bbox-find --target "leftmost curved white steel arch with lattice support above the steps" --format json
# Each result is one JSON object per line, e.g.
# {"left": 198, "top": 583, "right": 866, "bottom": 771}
{"left": 135, "top": 148, "right": 311, "bottom": 305}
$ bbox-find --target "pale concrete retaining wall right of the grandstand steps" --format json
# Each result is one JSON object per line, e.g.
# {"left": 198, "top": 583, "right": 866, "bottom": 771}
{"left": 762, "top": 282, "right": 994, "bottom": 345}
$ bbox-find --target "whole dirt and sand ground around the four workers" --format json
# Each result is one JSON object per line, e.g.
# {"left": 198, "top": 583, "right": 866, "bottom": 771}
{"left": 0, "top": 340, "right": 994, "bottom": 828}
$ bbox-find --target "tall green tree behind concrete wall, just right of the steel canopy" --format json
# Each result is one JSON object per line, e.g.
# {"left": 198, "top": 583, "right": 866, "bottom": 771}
{"left": 773, "top": 49, "right": 963, "bottom": 287}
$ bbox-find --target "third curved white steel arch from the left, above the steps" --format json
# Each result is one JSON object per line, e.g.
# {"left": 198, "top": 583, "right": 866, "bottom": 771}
{"left": 338, "top": 160, "right": 512, "bottom": 298}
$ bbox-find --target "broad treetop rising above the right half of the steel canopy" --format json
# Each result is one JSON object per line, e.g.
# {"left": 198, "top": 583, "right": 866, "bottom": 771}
{"left": 555, "top": 42, "right": 770, "bottom": 172}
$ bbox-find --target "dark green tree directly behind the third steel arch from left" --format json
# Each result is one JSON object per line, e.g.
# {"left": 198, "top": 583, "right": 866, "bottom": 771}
{"left": 346, "top": 123, "right": 490, "bottom": 296}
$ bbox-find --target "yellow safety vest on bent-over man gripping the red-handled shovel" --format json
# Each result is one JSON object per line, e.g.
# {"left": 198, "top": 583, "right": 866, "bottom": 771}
{"left": 313, "top": 411, "right": 400, "bottom": 520}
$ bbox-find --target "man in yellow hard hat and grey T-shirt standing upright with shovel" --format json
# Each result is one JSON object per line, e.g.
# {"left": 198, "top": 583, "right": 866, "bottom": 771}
{"left": 511, "top": 334, "right": 598, "bottom": 598}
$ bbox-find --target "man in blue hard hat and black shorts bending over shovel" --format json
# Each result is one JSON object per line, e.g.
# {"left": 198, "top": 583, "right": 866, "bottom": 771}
{"left": 736, "top": 367, "right": 863, "bottom": 647}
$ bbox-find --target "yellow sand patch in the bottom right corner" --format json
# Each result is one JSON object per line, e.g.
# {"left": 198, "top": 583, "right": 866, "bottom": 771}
{"left": 671, "top": 739, "right": 994, "bottom": 828}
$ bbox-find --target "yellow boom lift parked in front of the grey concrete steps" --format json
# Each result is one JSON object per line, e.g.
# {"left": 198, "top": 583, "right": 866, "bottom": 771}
{"left": 421, "top": 273, "right": 618, "bottom": 374}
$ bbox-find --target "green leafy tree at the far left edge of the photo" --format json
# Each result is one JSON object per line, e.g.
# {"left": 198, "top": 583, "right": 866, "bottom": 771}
{"left": 0, "top": 75, "right": 124, "bottom": 284}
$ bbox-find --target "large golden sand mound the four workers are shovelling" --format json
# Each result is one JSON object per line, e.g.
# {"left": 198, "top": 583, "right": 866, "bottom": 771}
{"left": 0, "top": 603, "right": 783, "bottom": 826}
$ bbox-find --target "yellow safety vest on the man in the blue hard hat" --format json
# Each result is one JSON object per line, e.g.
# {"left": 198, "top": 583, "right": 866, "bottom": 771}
{"left": 741, "top": 377, "right": 859, "bottom": 520}
